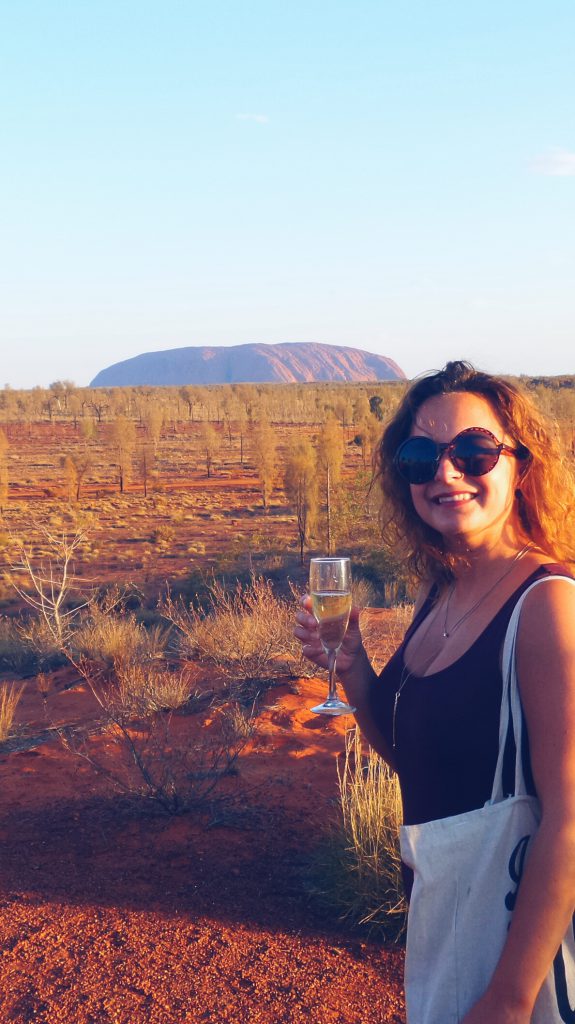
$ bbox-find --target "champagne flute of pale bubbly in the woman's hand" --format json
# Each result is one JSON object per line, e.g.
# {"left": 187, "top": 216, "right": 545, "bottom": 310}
{"left": 309, "top": 558, "right": 355, "bottom": 715}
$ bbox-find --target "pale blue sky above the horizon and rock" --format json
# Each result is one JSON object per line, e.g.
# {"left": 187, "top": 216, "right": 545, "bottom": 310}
{"left": 0, "top": 0, "right": 575, "bottom": 387}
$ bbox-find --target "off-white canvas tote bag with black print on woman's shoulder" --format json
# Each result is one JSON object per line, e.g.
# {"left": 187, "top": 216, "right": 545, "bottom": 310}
{"left": 400, "top": 577, "right": 575, "bottom": 1024}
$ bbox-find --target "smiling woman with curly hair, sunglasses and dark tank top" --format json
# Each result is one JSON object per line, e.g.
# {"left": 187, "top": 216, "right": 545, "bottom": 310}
{"left": 296, "top": 361, "right": 575, "bottom": 1024}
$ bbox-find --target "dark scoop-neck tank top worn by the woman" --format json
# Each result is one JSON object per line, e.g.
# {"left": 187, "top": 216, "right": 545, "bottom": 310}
{"left": 370, "top": 564, "right": 571, "bottom": 824}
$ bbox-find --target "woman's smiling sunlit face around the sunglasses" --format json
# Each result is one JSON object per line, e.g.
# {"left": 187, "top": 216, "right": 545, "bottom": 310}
{"left": 409, "top": 392, "right": 519, "bottom": 548}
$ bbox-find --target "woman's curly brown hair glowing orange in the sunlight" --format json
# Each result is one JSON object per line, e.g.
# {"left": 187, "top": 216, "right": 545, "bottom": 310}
{"left": 375, "top": 359, "right": 575, "bottom": 584}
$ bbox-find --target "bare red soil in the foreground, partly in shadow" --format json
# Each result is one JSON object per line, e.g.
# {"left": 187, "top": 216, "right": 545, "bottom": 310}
{"left": 0, "top": 670, "right": 404, "bottom": 1024}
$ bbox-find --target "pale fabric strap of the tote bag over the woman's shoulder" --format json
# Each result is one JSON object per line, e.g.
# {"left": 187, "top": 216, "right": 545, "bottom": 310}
{"left": 490, "top": 575, "right": 575, "bottom": 804}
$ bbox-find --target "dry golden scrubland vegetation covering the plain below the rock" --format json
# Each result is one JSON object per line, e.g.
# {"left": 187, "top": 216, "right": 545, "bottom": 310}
{"left": 0, "top": 378, "right": 575, "bottom": 937}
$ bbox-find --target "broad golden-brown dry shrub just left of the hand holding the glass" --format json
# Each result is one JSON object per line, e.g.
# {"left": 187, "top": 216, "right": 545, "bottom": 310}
{"left": 161, "top": 574, "right": 310, "bottom": 679}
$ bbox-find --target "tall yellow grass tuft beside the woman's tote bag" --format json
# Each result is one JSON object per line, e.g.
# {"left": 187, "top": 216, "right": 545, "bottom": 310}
{"left": 322, "top": 729, "right": 407, "bottom": 941}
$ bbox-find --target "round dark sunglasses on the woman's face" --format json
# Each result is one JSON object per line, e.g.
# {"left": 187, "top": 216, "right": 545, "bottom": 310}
{"left": 393, "top": 427, "right": 529, "bottom": 483}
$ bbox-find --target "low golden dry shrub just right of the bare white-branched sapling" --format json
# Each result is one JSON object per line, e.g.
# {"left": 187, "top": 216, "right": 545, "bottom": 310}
{"left": 72, "top": 604, "right": 170, "bottom": 667}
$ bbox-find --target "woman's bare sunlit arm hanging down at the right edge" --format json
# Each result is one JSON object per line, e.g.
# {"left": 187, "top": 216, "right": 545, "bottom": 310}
{"left": 463, "top": 581, "right": 575, "bottom": 1024}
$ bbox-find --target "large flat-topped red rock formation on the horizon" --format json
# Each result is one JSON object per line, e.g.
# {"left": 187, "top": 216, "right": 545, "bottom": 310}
{"left": 90, "top": 342, "right": 405, "bottom": 387}
